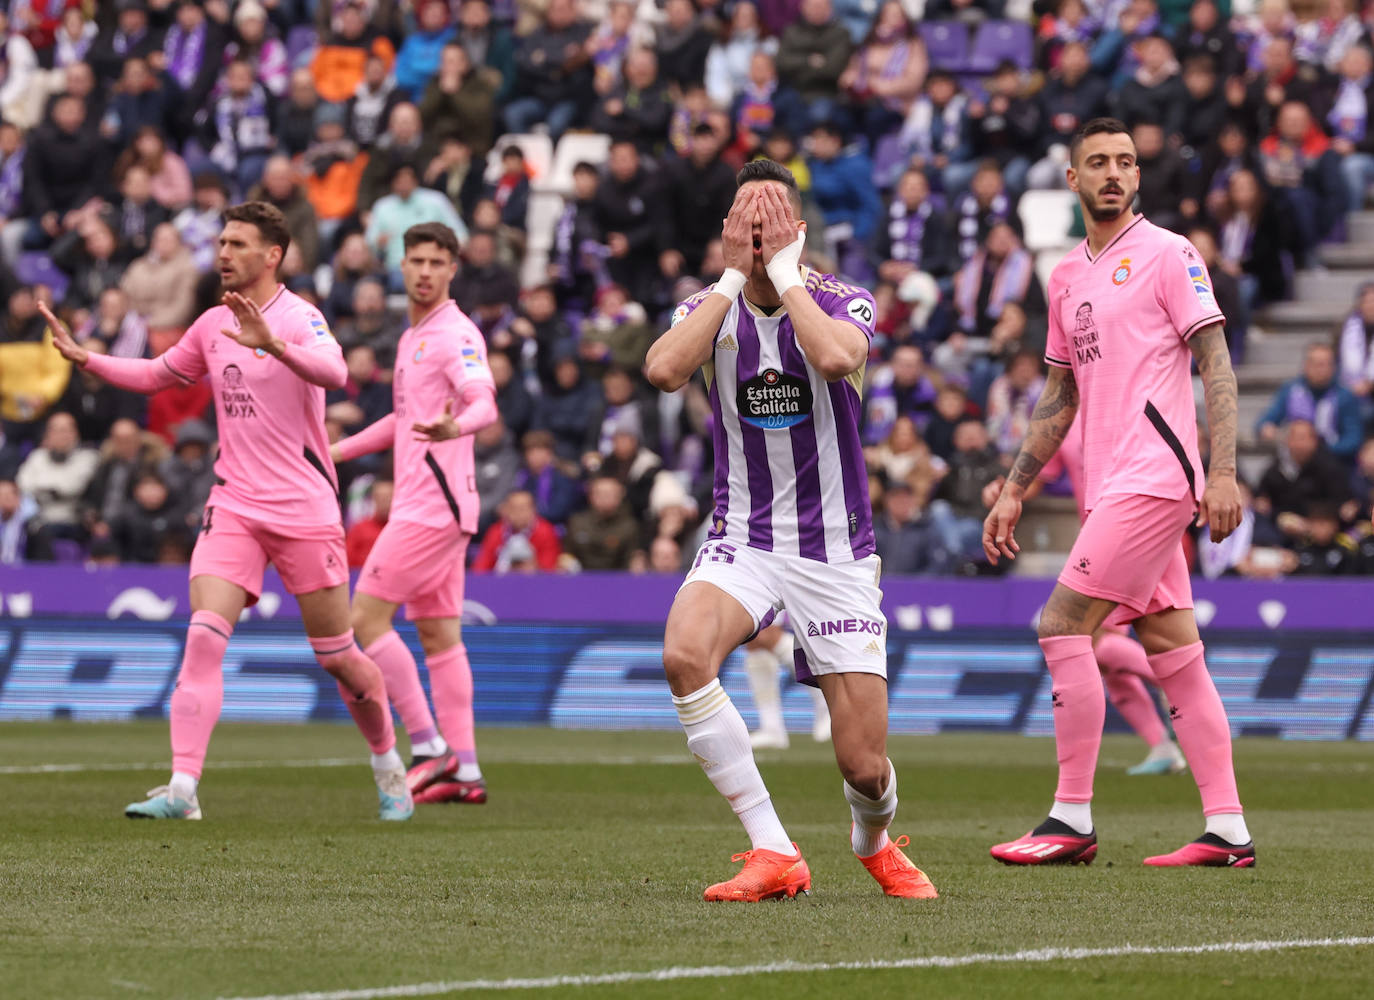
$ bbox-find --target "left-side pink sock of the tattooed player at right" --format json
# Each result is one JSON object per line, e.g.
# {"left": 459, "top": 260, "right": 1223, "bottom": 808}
{"left": 1040, "top": 636, "right": 1107, "bottom": 802}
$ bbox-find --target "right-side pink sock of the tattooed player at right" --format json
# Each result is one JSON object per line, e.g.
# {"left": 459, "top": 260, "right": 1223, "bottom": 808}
{"left": 1150, "top": 643, "right": 1241, "bottom": 816}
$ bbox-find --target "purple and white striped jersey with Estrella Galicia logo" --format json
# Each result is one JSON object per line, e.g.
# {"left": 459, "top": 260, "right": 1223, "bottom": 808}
{"left": 672, "top": 271, "right": 875, "bottom": 563}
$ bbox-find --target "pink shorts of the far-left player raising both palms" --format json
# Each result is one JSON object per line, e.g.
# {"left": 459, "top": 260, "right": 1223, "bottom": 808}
{"left": 191, "top": 504, "right": 348, "bottom": 607}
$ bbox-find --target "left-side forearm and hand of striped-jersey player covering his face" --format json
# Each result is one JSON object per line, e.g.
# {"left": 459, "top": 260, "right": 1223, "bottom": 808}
{"left": 644, "top": 188, "right": 754, "bottom": 393}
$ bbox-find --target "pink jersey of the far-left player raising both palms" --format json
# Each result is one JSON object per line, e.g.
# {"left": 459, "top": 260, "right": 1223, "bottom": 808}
{"left": 157, "top": 287, "right": 342, "bottom": 527}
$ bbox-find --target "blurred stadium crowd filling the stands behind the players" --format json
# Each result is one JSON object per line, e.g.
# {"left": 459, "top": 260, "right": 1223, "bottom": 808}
{"left": 0, "top": 0, "right": 1374, "bottom": 576}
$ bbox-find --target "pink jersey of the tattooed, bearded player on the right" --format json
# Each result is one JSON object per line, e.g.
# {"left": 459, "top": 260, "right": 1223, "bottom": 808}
{"left": 1044, "top": 217, "right": 1224, "bottom": 510}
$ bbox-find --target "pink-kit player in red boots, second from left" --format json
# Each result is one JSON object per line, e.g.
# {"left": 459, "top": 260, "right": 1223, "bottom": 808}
{"left": 333, "top": 223, "right": 497, "bottom": 804}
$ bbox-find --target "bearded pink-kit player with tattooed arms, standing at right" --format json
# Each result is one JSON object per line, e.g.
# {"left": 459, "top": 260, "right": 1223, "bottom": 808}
{"left": 982, "top": 118, "right": 1254, "bottom": 867}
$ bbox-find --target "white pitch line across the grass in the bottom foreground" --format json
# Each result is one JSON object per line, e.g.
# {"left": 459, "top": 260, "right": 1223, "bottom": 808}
{"left": 220, "top": 937, "right": 1374, "bottom": 1000}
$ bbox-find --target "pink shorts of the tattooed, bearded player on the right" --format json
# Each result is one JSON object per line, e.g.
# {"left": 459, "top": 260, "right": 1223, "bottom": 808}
{"left": 1059, "top": 493, "right": 1197, "bottom": 625}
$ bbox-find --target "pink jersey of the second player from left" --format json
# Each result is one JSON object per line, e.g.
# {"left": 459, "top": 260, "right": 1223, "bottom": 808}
{"left": 392, "top": 299, "right": 496, "bottom": 534}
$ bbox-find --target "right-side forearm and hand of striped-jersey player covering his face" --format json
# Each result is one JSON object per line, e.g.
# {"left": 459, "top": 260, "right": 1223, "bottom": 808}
{"left": 758, "top": 184, "right": 868, "bottom": 382}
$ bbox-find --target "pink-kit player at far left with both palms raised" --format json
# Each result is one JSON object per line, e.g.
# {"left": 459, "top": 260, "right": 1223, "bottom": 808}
{"left": 44, "top": 202, "right": 414, "bottom": 820}
